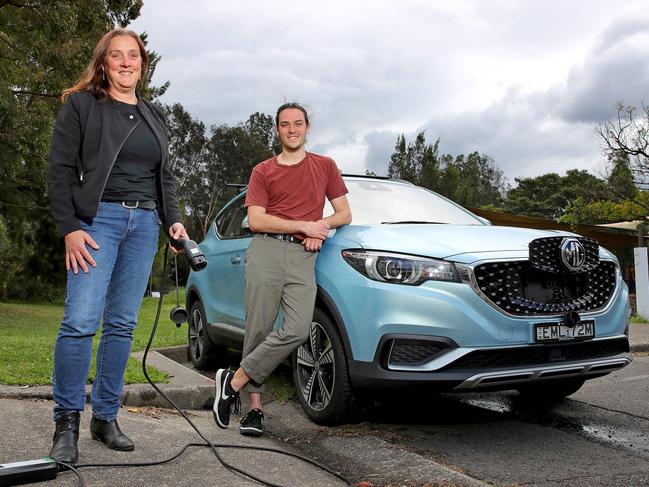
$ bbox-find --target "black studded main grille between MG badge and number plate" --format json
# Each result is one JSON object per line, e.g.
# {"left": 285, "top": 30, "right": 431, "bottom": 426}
{"left": 474, "top": 261, "right": 616, "bottom": 316}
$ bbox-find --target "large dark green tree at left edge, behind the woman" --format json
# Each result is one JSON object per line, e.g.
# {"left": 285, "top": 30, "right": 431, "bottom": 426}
{"left": 0, "top": 0, "right": 151, "bottom": 298}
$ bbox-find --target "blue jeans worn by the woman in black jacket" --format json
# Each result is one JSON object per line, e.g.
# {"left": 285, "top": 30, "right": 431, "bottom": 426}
{"left": 52, "top": 202, "right": 160, "bottom": 421}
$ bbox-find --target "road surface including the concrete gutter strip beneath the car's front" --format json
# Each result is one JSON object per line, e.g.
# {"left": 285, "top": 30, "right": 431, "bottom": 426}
{"left": 177, "top": 348, "right": 649, "bottom": 487}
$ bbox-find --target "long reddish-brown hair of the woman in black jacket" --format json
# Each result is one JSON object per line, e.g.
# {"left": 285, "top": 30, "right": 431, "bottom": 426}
{"left": 61, "top": 29, "right": 149, "bottom": 101}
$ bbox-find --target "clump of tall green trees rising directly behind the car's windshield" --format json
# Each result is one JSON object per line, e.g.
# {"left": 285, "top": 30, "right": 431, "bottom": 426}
{"left": 388, "top": 131, "right": 507, "bottom": 207}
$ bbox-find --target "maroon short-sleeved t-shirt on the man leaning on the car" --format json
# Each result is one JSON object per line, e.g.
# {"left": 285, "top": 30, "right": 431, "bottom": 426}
{"left": 246, "top": 152, "right": 347, "bottom": 221}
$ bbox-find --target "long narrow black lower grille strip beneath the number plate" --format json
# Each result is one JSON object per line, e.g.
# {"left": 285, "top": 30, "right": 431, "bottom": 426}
{"left": 444, "top": 338, "right": 629, "bottom": 370}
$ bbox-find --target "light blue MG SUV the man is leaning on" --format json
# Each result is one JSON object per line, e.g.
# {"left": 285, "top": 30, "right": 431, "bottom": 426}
{"left": 187, "top": 176, "right": 631, "bottom": 423}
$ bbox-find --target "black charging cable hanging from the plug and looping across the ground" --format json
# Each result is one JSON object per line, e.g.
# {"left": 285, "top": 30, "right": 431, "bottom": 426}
{"left": 59, "top": 247, "right": 353, "bottom": 487}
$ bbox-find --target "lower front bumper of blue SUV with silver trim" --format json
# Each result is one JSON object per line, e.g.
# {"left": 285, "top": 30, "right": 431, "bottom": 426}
{"left": 349, "top": 335, "right": 632, "bottom": 391}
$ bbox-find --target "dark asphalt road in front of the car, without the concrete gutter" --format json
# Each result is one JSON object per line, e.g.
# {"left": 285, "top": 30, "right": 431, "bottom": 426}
{"left": 330, "top": 356, "right": 649, "bottom": 487}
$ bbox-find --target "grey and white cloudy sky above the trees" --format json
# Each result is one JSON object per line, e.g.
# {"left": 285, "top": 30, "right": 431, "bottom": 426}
{"left": 131, "top": 0, "right": 649, "bottom": 183}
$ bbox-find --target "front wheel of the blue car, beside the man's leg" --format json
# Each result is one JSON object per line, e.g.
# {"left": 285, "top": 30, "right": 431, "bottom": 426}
{"left": 292, "top": 308, "right": 358, "bottom": 425}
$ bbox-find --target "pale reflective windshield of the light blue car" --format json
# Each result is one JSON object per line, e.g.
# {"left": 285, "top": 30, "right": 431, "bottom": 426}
{"left": 324, "top": 178, "right": 484, "bottom": 225}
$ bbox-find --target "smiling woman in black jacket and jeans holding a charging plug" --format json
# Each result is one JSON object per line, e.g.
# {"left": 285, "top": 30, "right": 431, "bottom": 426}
{"left": 48, "top": 29, "right": 188, "bottom": 463}
